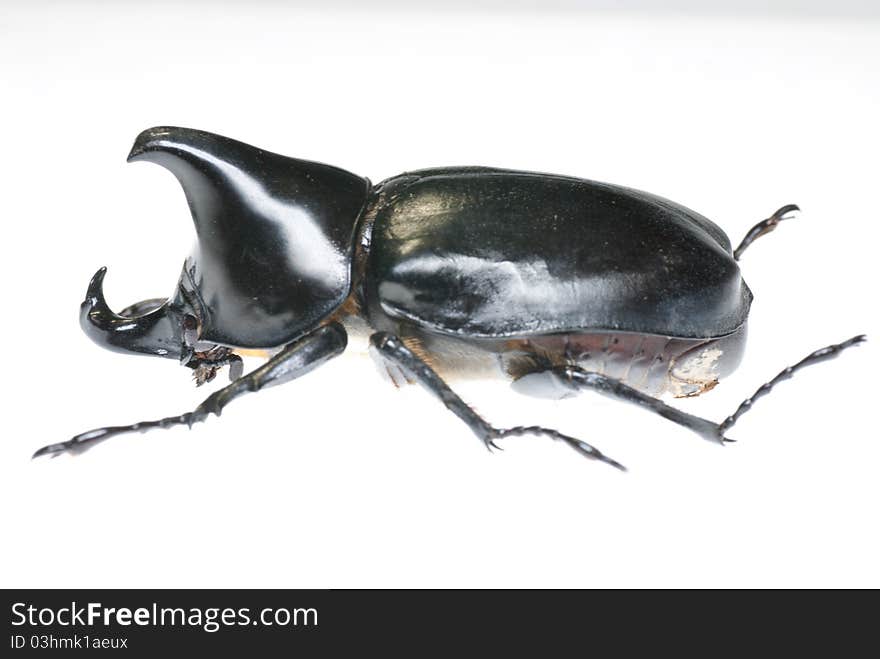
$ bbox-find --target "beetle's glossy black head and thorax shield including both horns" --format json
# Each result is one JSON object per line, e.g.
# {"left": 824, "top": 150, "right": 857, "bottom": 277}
{"left": 81, "top": 127, "right": 370, "bottom": 360}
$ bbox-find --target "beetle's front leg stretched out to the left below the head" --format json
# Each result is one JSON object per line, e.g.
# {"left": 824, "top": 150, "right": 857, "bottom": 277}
{"left": 34, "top": 323, "right": 347, "bottom": 458}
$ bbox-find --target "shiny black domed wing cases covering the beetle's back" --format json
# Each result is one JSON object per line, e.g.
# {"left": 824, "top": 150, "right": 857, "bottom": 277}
{"left": 365, "top": 168, "right": 751, "bottom": 338}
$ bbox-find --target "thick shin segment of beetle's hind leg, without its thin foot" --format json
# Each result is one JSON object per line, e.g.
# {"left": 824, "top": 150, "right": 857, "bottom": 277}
{"left": 549, "top": 366, "right": 724, "bottom": 443}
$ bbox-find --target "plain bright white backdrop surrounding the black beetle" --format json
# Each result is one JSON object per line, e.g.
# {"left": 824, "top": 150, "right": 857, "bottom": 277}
{"left": 0, "top": 1, "right": 880, "bottom": 587}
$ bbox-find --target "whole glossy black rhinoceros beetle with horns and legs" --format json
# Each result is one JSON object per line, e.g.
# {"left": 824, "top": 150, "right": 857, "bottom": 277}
{"left": 35, "top": 127, "right": 865, "bottom": 468}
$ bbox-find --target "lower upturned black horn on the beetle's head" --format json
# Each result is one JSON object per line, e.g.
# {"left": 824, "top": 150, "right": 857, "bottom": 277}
{"left": 79, "top": 268, "right": 183, "bottom": 359}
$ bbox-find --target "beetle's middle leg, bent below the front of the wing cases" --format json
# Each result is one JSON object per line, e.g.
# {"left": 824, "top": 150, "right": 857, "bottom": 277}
{"left": 370, "top": 332, "right": 626, "bottom": 471}
